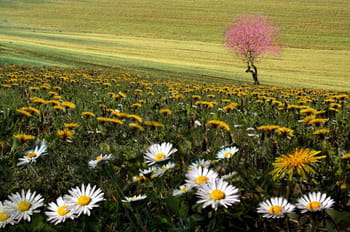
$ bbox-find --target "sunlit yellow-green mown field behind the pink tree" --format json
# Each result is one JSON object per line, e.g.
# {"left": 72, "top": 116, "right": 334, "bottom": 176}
{"left": 0, "top": 0, "right": 350, "bottom": 90}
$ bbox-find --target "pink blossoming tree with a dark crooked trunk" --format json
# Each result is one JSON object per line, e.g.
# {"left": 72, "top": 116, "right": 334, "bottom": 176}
{"left": 225, "top": 15, "right": 281, "bottom": 85}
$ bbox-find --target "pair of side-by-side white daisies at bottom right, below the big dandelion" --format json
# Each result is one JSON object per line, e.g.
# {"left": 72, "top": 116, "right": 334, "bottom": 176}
{"left": 257, "top": 192, "right": 335, "bottom": 218}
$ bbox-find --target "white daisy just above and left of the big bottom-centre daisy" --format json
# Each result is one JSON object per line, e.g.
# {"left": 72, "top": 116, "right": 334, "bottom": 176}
{"left": 186, "top": 167, "right": 219, "bottom": 186}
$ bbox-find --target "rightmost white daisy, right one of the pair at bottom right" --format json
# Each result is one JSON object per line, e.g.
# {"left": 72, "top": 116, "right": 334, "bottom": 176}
{"left": 296, "top": 192, "right": 335, "bottom": 213}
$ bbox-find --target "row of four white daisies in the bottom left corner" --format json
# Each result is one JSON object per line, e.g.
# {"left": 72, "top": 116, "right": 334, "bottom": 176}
{"left": 0, "top": 184, "right": 105, "bottom": 228}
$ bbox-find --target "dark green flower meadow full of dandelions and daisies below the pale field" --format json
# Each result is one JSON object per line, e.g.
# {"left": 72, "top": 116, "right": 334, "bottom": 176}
{"left": 0, "top": 65, "right": 350, "bottom": 231}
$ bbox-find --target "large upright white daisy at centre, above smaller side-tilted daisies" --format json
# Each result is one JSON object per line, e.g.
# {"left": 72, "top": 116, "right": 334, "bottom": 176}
{"left": 144, "top": 142, "right": 177, "bottom": 165}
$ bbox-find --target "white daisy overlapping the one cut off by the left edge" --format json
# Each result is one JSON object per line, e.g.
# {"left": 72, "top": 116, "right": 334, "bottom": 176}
{"left": 4, "top": 189, "right": 44, "bottom": 222}
